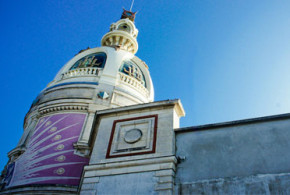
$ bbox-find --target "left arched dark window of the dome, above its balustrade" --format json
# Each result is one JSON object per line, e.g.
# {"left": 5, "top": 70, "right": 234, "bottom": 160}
{"left": 70, "top": 52, "right": 107, "bottom": 70}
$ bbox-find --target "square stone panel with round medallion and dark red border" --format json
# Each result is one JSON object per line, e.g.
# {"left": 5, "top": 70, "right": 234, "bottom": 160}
{"left": 106, "top": 115, "right": 158, "bottom": 158}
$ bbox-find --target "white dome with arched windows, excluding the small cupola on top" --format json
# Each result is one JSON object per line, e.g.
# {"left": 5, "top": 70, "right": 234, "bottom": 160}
{"left": 44, "top": 47, "right": 154, "bottom": 108}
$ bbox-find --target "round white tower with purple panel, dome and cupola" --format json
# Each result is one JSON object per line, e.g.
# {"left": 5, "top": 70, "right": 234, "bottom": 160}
{"left": 2, "top": 10, "right": 161, "bottom": 194}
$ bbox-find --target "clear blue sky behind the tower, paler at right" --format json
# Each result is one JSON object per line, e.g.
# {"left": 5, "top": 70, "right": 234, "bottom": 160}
{"left": 0, "top": 0, "right": 290, "bottom": 170}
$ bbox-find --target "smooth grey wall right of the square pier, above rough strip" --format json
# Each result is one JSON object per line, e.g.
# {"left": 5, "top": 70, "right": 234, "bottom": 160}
{"left": 176, "top": 116, "right": 290, "bottom": 184}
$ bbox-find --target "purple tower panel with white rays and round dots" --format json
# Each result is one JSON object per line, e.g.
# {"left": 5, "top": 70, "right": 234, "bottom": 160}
{"left": 6, "top": 113, "right": 89, "bottom": 187}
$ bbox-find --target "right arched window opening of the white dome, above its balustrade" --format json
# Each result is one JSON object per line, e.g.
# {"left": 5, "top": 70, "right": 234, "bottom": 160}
{"left": 119, "top": 61, "right": 146, "bottom": 87}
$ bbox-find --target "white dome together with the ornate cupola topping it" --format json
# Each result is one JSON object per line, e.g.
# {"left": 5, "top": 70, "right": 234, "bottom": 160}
{"left": 30, "top": 10, "right": 154, "bottom": 115}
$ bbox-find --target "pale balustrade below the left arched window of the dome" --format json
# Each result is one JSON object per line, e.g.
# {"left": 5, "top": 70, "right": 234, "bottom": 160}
{"left": 62, "top": 68, "right": 100, "bottom": 79}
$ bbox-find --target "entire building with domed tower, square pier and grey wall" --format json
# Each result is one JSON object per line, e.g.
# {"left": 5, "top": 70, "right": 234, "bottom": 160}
{"left": 0, "top": 10, "right": 290, "bottom": 194}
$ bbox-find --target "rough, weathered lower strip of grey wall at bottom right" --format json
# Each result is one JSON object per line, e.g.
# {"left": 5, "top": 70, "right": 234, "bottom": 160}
{"left": 176, "top": 174, "right": 290, "bottom": 194}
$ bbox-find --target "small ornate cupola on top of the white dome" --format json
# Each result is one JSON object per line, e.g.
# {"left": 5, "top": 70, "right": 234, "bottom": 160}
{"left": 101, "top": 10, "right": 138, "bottom": 54}
